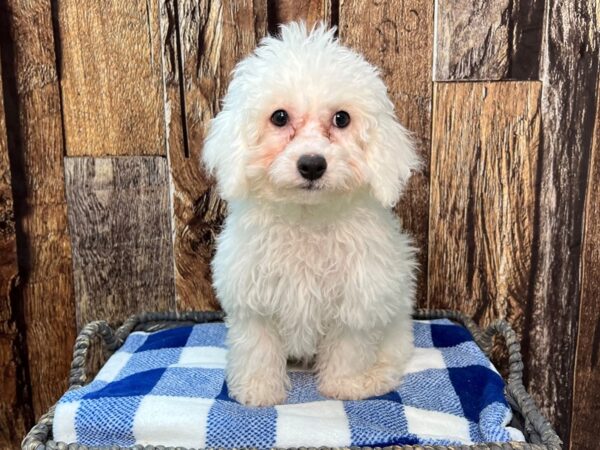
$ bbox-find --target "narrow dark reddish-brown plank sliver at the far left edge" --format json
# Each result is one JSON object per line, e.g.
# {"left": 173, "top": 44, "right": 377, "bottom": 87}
{"left": 0, "top": 44, "right": 29, "bottom": 448}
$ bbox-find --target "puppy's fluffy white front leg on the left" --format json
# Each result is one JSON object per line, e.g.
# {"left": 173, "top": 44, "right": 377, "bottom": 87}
{"left": 227, "top": 315, "right": 289, "bottom": 406}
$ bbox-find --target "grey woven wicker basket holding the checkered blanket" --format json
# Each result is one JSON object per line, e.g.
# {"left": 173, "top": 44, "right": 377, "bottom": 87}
{"left": 22, "top": 310, "right": 562, "bottom": 450}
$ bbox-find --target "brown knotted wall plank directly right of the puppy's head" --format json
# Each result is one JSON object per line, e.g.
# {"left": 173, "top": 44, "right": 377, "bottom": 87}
{"left": 339, "top": 0, "right": 433, "bottom": 306}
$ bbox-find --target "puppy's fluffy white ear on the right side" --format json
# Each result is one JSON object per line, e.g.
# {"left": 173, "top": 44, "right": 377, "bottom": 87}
{"left": 367, "top": 114, "right": 421, "bottom": 207}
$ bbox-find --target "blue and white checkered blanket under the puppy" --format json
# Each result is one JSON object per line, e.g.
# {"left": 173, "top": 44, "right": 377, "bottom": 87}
{"left": 53, "top": 320, "right": 523, "bottom": 448}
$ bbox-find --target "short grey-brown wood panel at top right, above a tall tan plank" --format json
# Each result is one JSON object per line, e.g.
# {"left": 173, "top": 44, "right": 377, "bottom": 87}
{"left": 434, "top": 0, "right": 544, "bottom": 81}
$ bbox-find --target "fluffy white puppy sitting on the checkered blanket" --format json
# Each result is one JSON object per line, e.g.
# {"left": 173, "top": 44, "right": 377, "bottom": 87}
{"left": 203, "top": 23, "right": 419, "bottom": 405}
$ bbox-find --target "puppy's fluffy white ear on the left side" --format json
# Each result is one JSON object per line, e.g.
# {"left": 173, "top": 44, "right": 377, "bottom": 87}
{"left": 202, "top": 105, "right": 247, "bottom": 200}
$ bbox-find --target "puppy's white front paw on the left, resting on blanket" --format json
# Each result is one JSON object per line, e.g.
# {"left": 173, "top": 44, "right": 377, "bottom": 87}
{"left": 229, "top": 375, "right": 287, "bottom": 406}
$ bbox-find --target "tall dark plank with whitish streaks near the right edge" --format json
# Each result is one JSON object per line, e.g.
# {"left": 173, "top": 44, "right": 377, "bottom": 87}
{"left": 523, "top": 0, "right": 600, "bottom": 442}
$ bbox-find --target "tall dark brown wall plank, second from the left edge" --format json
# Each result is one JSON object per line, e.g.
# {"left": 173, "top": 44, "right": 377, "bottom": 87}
{"left": 0, "top": 0, "right": 76, "bottom": 416}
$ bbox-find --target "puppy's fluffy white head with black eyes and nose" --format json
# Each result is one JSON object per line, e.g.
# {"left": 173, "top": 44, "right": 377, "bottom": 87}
{"left": 203, "top": 23, "right": 419, "bottom": 206}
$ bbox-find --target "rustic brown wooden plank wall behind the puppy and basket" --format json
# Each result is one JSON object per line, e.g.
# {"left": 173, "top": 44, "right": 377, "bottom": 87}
{"left": 0, "top": 0, "right": 600, "bottom": 449}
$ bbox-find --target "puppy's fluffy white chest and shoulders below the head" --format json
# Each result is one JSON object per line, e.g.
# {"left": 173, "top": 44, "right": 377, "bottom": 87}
{"left": 213, "top": 202, "right": 404, "bottom": 359}
